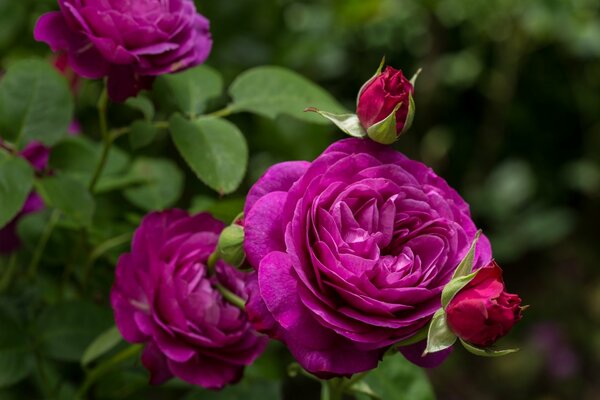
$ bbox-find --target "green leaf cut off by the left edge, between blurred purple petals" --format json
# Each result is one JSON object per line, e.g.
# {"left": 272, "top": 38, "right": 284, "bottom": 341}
{"left": 0, "top": 151, "right": 33, "bottom": 228}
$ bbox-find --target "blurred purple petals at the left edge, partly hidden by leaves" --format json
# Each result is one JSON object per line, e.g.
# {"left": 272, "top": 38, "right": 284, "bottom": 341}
{"left": 0, "top": 141, "right": 50, "bottom": 254}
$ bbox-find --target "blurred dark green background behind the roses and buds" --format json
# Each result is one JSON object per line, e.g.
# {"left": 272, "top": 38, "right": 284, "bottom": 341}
{"left": 0, "top": 0, "right": 600, "bottom": 400}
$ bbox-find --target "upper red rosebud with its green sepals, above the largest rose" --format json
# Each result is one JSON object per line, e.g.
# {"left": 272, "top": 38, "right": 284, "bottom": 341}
{"left": 356, "top": 67, "right": 415, "bottom": 144}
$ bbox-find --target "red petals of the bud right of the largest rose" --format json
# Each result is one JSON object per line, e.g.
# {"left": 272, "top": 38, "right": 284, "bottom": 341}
{"left": 446, "top": 261, "right": 522, "bottom": 347}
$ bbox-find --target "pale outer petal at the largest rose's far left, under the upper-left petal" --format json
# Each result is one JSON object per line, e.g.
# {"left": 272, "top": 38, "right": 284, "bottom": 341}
{"left": 244, "top": 192, "right": 286, "bottom": 268}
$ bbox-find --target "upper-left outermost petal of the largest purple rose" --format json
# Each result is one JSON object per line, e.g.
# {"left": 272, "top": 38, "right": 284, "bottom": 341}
{"left": 244, "top": 161, "right": 310, "bottom": 214}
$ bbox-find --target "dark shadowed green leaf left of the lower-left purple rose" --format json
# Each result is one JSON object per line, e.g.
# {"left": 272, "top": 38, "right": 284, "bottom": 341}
{"left": 35, "top": 301, "right": 113, "bottom": 362}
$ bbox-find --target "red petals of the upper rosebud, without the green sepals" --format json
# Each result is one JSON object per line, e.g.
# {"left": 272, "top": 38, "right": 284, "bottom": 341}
{"left": 356, "top": 67, "right": 414, "bottom": 135}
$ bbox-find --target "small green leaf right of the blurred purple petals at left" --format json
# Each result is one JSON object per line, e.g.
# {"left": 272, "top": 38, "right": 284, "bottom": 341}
{"left": 36, "top": 175, "right": 96, "bottom": 226}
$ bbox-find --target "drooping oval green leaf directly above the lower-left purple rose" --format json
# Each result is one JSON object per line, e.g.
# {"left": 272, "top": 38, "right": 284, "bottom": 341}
{"left": 169, "top": 114, "right": 248, "bottom": 194}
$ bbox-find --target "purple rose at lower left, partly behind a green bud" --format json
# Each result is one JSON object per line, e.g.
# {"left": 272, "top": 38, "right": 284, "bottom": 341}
{"left": 111, "top": 210, "right": 267, "bottom": 389}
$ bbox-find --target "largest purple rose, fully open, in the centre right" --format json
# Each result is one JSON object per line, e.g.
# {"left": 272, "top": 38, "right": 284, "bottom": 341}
{"left": 244, "top": 139, "right": 491, "bottom": 377}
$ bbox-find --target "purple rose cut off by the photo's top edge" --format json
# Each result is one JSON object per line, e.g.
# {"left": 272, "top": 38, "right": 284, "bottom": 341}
{"left": 34, "top": 0, "right": 212, "bottom": 101}
